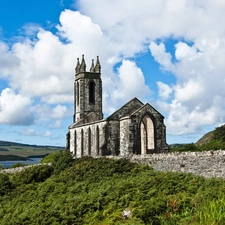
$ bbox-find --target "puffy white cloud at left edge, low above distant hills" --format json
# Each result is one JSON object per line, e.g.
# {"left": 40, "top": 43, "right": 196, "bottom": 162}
{"left": 0, "top": 88, "right": 34, "bottom": 125}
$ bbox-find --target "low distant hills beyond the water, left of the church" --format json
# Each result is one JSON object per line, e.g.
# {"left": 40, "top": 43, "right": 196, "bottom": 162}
{"left": 0, "top": 141, "right": 64, "bottom": 161}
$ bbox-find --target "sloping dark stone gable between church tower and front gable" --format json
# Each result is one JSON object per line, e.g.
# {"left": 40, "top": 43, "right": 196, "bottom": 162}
{"left": 107, "top": 98, "right": 144, "bottom": 120}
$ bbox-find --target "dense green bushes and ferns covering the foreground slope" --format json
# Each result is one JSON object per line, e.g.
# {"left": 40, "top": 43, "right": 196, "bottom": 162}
{"left": 0, "top": 151, "right": 225, "bottom": 225}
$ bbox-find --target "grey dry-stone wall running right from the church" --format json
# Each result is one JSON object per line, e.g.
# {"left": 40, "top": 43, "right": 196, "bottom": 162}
{"left": 104, "top": 150, "right": 225, "bottom": 178}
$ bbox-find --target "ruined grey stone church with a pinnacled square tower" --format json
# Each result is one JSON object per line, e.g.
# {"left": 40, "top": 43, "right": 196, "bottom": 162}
{"left": 67, "top": 55, "right": 168, "bottom": 157}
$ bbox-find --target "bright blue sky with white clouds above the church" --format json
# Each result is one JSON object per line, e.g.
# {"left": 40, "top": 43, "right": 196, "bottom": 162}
{"left": 0, "top": 0, "right": 225, "bottom": 146}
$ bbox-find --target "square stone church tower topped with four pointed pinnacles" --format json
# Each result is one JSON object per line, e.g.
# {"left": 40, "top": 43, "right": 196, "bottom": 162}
{"left": 74, "top": 55, "right": 103, "bottom": 124}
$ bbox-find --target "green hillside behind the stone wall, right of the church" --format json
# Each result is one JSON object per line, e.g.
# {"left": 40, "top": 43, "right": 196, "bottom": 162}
{"left": 170, "top": 125, "right": 225, "bottom": 152}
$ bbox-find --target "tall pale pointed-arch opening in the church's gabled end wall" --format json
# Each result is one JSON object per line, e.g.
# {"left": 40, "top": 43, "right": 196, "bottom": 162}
{"left": 140, "top": 115, "right": 155, "bottom": 154}
